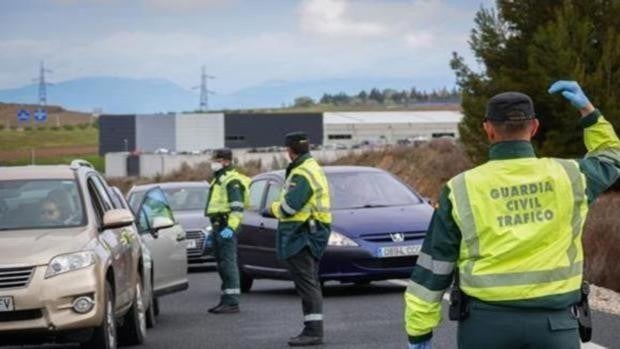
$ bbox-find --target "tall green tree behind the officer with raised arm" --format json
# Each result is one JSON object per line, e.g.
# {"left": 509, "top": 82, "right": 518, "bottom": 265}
{"left": 451, "top": 0, "right": 620, "bottom": 163}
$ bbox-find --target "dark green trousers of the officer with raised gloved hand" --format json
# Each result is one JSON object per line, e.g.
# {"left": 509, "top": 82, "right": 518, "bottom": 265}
{"left": 457, "top": 300, "right": 581, "bottom": 349}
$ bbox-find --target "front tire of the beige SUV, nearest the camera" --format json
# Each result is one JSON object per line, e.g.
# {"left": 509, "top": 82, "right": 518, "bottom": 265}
{"left": 80, "top": 281, "right": 118, "bottom": 349}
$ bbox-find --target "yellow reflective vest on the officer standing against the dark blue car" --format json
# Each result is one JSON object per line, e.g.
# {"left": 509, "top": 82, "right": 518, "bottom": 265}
{"left": 278, "top": 158, "right": 332, "bottom": 223}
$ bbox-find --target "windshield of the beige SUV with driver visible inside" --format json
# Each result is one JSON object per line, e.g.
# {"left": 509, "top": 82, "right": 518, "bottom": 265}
{"left": 0, "top": 179, "right": 86, "bottom": 230}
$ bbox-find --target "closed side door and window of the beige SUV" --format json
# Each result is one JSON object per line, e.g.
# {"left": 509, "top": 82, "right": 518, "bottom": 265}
{"left": 87, "top": 174, "right": 133, "bottom": 308}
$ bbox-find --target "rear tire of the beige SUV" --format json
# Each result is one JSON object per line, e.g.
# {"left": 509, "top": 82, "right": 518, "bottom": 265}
{"left": 119, "top": 275, "right": 147, "bottom": 345}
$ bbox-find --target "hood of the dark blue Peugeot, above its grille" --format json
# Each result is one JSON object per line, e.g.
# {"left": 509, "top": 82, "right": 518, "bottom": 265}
{"left": 332, "top": 204, "right": 433, "bottom": 238}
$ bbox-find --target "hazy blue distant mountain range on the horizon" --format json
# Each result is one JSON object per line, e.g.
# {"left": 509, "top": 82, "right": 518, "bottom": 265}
{"left": 0, "top": 77, "right": 456, "bottom": 114}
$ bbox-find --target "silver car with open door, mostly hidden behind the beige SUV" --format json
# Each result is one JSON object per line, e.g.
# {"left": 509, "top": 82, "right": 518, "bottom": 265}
{"left": 112, "top": 187, "right": 189, "bottom": 327}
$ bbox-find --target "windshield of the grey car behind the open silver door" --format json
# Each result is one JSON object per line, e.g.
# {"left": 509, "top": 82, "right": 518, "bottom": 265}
{"left": 129, "top": 186, "right": 209, "bottom": 212}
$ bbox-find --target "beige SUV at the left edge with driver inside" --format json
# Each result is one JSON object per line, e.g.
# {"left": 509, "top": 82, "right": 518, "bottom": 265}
{"left": 0, "top": 161, "right": 162, "bottom": 348}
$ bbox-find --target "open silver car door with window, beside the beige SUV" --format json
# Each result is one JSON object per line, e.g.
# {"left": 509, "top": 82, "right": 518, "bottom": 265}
{"left": 136, "top": 187, "right": 188, "bottom": 294}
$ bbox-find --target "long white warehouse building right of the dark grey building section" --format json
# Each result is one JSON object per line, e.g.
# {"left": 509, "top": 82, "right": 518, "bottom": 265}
{"left": 323, "top": 110, "right": 463, "bottom": 146}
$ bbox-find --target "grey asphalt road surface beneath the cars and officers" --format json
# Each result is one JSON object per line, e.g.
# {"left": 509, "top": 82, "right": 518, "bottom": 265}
{"left": 130, "top": 272, "right": 620, "bottom": 349}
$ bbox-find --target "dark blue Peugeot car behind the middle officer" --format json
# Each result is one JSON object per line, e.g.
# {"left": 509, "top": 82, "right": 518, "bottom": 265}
{"left": 239, "top": 166, "right": 433, "bottom": 292}
